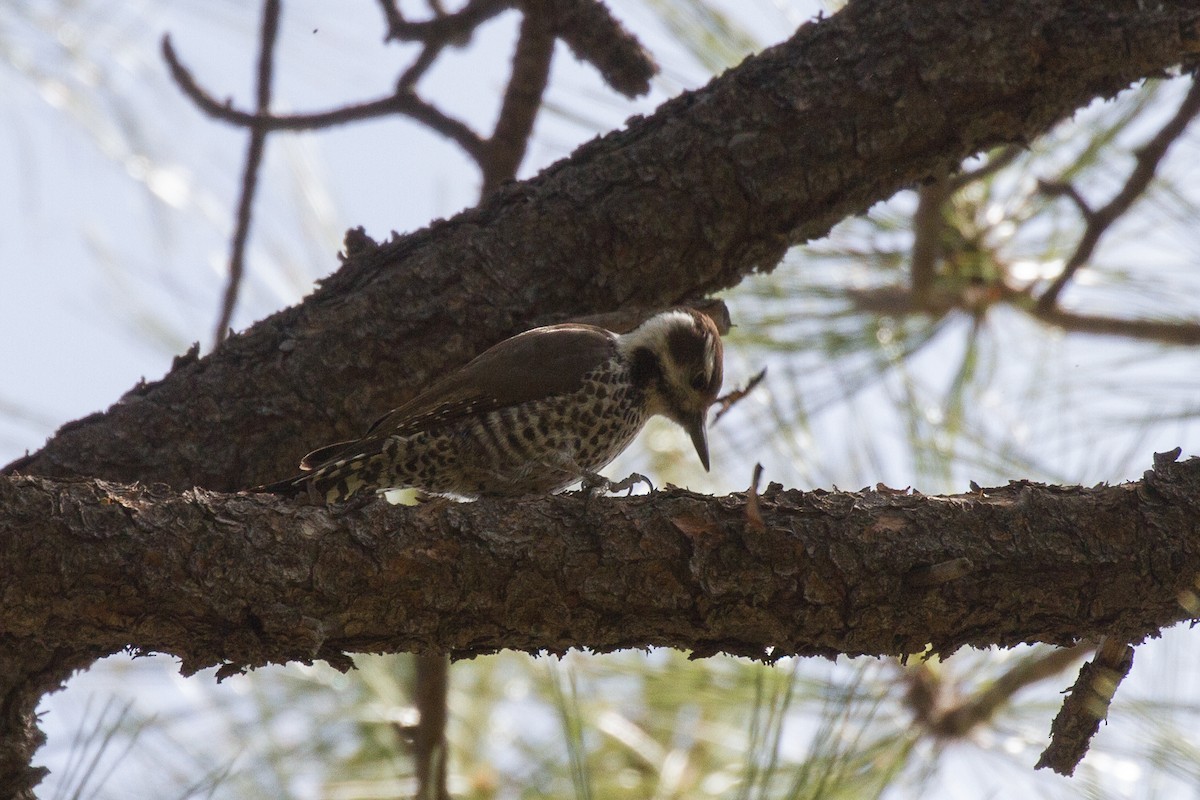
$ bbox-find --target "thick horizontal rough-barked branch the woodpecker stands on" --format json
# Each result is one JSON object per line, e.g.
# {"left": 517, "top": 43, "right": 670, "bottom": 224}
{"left": 0, "top": 458, "right": 1200, "bottom": 786}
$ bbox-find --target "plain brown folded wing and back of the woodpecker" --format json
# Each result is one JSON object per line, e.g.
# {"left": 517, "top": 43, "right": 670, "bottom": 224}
{"left": 300, "top": 323, "right": 617, "bottom": 469}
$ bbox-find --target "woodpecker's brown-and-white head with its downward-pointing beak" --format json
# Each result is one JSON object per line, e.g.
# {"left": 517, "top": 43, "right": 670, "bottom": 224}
{"left": 618, "top": 308, "right": 722, "bottom": 470}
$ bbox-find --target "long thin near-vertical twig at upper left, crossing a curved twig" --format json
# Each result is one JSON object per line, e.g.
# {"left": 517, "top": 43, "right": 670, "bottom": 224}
{"left": 212, "top": 0, "right": 280, "bottom": 347}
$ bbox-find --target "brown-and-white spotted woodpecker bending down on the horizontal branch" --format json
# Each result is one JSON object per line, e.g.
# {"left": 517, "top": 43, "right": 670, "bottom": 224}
{"left": 257, "top": 307, "right": 724, "bottom": 504}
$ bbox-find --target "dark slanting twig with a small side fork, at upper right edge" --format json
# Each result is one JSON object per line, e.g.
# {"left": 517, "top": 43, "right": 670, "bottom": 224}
{"left": 1038, "top": 79, "right": 1200, "bottom": 312}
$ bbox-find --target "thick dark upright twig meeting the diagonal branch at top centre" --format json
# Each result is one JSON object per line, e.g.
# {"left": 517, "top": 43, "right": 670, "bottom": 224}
{"left": 476, "top": 0, "right": 554, "bottom": 196}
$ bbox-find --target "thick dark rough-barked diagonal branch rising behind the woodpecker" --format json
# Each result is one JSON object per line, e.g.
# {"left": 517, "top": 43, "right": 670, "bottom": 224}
{"left": 7, "top": 0, "right": 1200, "bottom": 491}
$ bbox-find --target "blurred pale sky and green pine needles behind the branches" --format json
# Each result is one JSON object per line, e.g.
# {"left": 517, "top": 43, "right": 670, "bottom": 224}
{"left": 7, "top": 0, "right": 1200, "bottom": 800}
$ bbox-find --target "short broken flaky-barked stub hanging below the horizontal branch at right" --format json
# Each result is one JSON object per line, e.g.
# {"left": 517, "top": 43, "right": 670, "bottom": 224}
{"left": 1034, "top": 637, "right": 1133, "bottom": 776}
